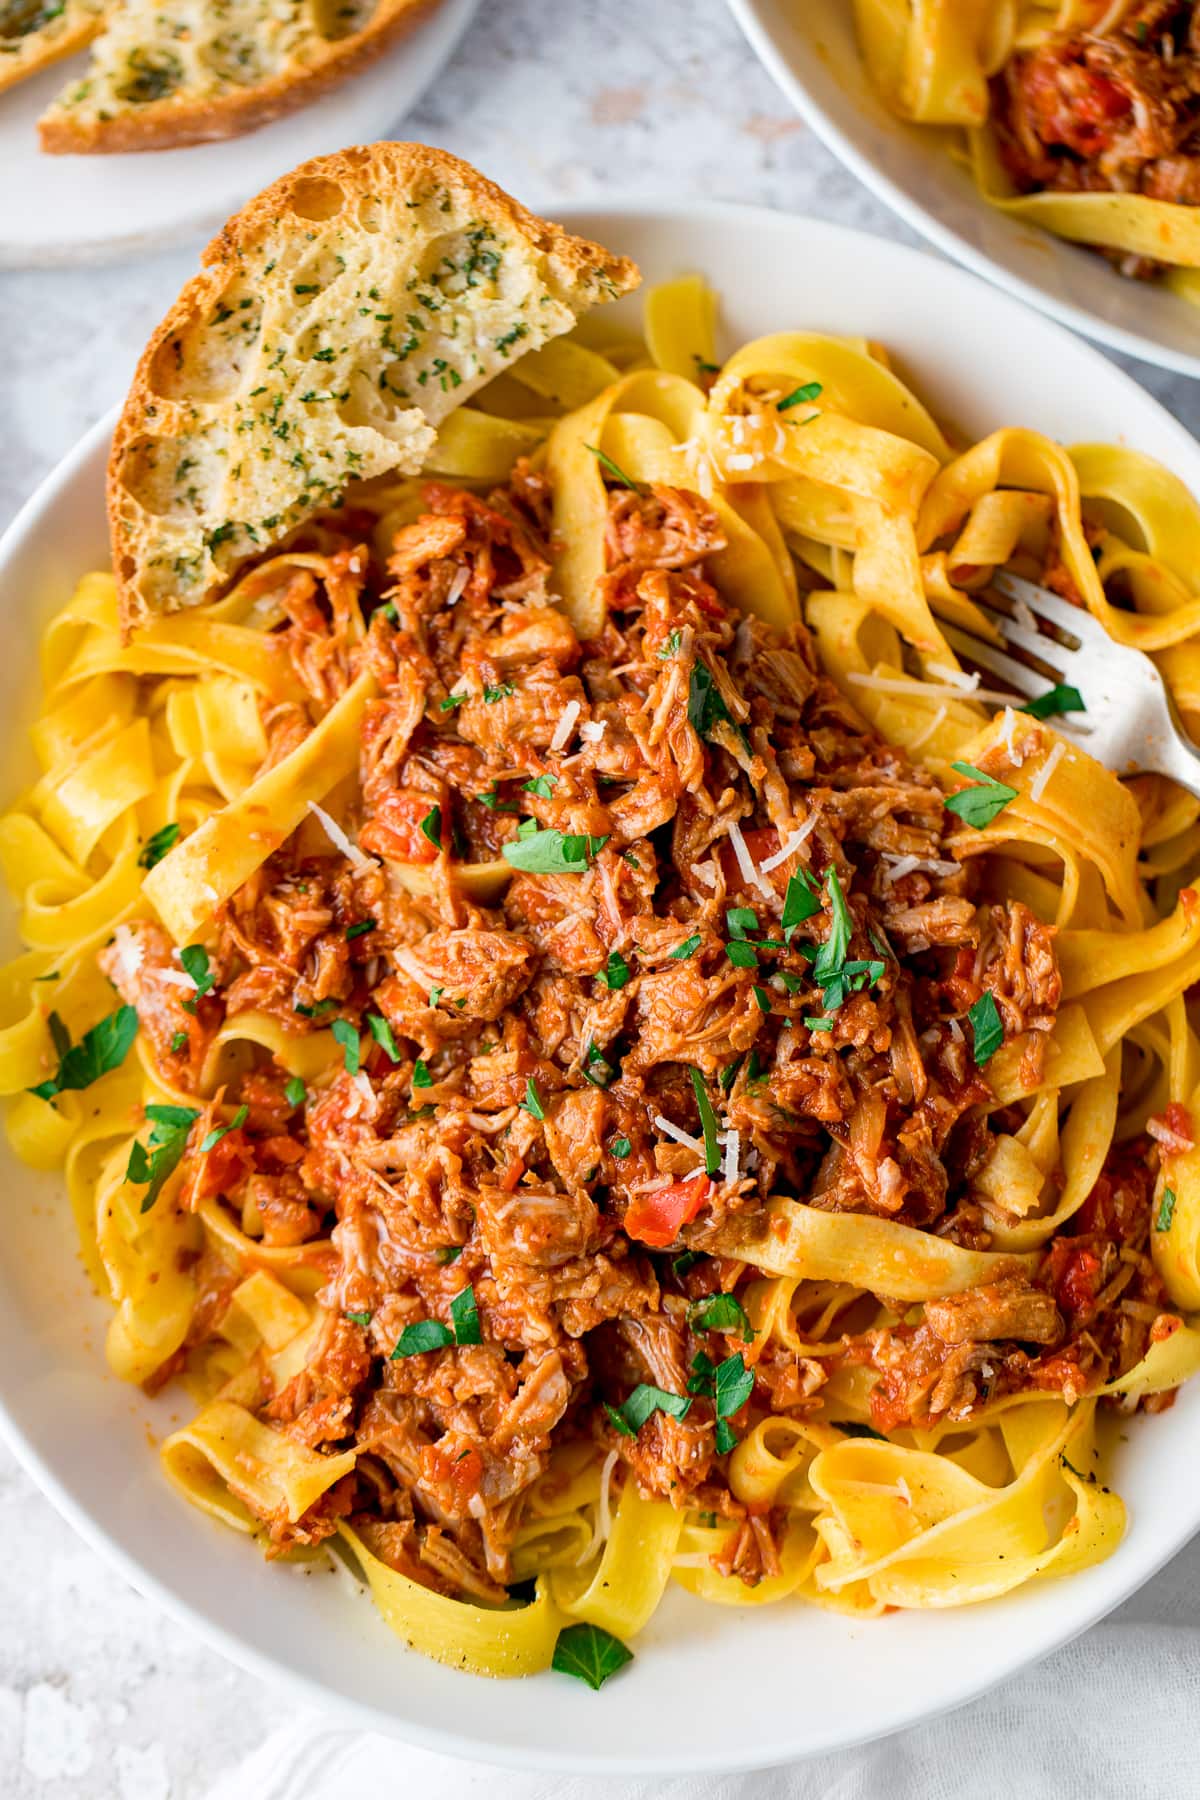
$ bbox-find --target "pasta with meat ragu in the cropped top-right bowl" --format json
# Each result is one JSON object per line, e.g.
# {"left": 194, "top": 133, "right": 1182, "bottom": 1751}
{"left": 855, "top": 0, "right": 1200, "bottom": 299}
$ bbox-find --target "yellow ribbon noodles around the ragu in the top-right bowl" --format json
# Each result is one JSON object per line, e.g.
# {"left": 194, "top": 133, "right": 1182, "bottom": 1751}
{"left": 855, "top": 0, "right": 1200, "bottom": 299}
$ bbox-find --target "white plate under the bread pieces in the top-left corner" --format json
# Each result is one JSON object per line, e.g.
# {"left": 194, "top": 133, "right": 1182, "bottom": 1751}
{"left": 0, "top": 0, "right": 479, "bottom": 268}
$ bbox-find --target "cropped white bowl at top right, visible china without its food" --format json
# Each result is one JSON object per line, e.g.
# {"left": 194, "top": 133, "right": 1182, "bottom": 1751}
{"left": 729, "top": 0, "right": 1200, "bottom": 374}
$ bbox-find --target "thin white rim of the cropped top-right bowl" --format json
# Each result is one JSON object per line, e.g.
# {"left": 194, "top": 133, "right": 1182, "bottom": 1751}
{"left": 727, "top": 0, "right": 1200, "bottom": 380}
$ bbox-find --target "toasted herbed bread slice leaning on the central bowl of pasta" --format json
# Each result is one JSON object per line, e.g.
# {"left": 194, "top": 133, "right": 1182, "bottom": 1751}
{"left": 108, "top": 144, "right": 639, "bottom": 628}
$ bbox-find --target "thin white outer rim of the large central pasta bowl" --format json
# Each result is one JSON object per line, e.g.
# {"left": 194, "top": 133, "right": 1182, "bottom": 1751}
{"left": 0, "top": 194, "right": 1200, "bottom": 1777}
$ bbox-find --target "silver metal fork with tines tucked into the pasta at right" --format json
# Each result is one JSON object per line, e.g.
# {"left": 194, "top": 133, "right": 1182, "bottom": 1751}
{"left": 943, "top": 574, "right": 1200, "bottom": 796}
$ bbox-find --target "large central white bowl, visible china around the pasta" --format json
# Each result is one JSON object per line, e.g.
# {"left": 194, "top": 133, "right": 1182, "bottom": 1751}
{"left": 0, "top": 205, "right": 1200, "bottom": 1775}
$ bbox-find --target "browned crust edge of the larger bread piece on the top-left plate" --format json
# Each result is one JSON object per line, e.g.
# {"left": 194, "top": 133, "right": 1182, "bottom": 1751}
{"left": 38, "top": 0, "right": 441, "bottom": 157}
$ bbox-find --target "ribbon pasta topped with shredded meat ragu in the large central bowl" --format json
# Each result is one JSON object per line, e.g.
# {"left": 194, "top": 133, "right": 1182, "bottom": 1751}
{"left": 0, "top": 277, "right": 1200, "bottom": 1685}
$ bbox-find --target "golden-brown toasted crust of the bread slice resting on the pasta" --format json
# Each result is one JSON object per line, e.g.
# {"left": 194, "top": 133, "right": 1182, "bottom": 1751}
{"left": 108, "top": 144, "right": 640, "bottom": 635}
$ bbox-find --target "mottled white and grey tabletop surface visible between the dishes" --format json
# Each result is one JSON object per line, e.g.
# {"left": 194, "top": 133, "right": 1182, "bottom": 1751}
{"left": 0, "top": 0, "right": 1200, "bottom": 1800}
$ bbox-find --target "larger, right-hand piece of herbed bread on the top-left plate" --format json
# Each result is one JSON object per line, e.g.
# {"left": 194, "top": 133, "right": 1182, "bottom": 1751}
{"left": 37, "top": 0, "right": 435, "bottom": 153}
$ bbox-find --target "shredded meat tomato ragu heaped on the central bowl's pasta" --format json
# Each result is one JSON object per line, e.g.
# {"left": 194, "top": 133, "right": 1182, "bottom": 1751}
{"left": 101, "top": 464, "right": 1191, "bottom": 1600}
